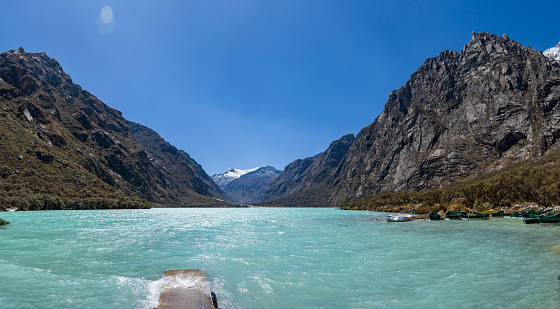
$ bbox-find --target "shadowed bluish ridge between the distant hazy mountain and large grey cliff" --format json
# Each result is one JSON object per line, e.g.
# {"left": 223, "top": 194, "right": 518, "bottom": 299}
{"left": 263, "top": 134, "right": 354, "bottom": 201}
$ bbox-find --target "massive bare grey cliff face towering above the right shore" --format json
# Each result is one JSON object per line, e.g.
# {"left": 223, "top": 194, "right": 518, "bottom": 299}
{"left": 329, "top": 33, "right": 560, "bottom": 205}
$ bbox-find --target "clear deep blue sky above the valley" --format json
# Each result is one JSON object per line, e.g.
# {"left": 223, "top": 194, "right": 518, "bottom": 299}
{"left": 0, "top": 0, "right": 560, "bottom": 174}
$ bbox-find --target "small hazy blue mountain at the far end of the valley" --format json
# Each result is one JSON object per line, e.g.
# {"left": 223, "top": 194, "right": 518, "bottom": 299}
{"left": 219, "top": 166, "right": 282, "bottom": 204}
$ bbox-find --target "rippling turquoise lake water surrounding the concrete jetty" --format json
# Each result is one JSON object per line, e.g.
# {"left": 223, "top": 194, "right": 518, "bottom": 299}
{"left": 0, "top": 208, "right": 560, "bottom": 309}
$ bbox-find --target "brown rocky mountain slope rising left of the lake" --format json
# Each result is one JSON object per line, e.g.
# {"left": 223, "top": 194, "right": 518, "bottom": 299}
{"left": 0, "top": 48, "right": 230, "bottom": 209}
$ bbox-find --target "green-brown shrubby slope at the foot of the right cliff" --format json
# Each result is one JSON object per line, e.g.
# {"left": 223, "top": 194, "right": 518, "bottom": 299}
{"left": 341, "top": 150, "right": 560, "bottom": 212}
